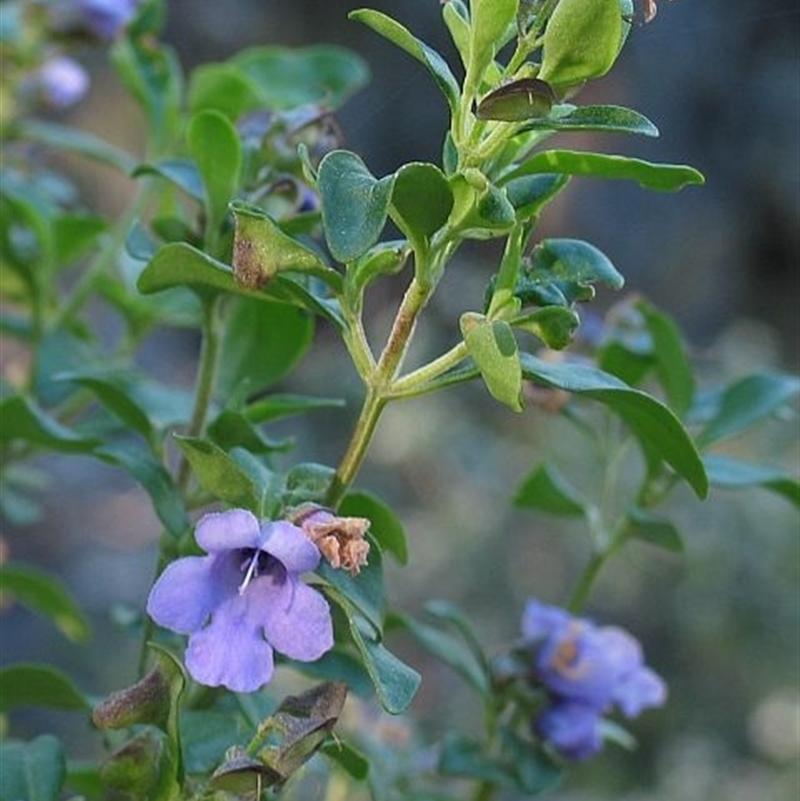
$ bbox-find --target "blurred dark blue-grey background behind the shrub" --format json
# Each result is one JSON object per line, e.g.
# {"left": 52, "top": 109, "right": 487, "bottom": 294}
{"left": 3, "top": 0, "right": 800, "bottom": 801}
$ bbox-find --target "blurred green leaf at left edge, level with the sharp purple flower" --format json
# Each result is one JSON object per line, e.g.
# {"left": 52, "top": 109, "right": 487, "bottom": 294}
{"left": 0, "top": 562, "right": 89, "bottom": 641}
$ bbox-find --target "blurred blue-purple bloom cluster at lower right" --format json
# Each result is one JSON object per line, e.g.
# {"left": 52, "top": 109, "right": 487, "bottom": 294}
{"left": 522, "top": 599, "right": 667, "bottom": 759}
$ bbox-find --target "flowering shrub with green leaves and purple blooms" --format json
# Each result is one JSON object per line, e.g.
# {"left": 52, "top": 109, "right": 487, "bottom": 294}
{"left": 0, "top": 0, "right": 800, "bottom": 801}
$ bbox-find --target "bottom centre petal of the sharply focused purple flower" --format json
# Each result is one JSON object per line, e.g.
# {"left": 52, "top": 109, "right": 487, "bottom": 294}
{"left": 185, "top": 592, "right": 274, "bottom": 693}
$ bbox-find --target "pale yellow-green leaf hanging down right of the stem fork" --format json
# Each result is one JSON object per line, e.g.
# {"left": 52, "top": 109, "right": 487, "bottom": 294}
{"left": 460, "top": 312, "right": 522, "bottom": 412}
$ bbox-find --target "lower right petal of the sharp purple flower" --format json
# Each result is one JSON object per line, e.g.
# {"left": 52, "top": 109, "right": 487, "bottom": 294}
{"left": 252, "top": 577, "right": 333, "bottom": 662}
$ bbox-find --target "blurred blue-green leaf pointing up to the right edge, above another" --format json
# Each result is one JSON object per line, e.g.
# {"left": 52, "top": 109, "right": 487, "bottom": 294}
{"left": 697, "top": 373, "right": 800, "bottom": 447}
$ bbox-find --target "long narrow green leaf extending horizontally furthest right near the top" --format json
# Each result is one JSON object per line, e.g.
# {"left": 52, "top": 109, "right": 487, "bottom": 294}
{"left": 503, "top": 150, "right": 705, "bottom": 192}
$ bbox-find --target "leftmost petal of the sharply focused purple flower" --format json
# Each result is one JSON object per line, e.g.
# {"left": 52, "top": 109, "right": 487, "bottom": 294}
{"left": 147, "top": 556, "right": 239, "bottom": 634}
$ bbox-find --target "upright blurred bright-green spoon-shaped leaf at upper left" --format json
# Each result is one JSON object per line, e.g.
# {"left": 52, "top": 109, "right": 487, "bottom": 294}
{"left": 186, "top": 110, "right": 242, "bottom": 236}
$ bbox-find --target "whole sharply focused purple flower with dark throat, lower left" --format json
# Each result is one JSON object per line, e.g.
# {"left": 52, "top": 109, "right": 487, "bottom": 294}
{"left": 147, "top": 509, "right": 333, "bottom": 692}
